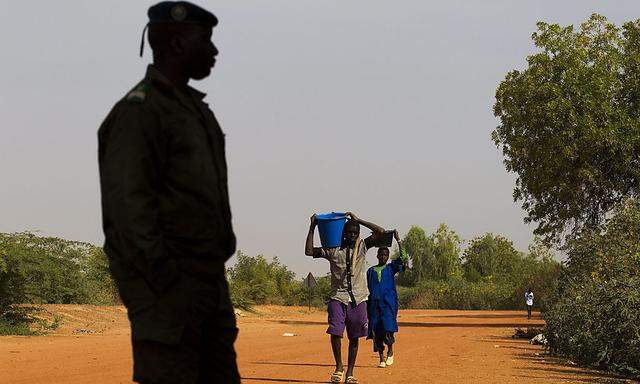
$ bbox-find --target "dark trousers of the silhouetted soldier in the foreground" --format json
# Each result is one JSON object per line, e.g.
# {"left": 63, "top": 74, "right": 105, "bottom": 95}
{"left": 116, "top": 273, "right": 240, "bottom": 384}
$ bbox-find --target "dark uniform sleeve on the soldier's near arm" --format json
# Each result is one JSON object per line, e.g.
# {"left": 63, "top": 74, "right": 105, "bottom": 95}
{"left": 99, "top": 104, "right": 178, "bottom": 291}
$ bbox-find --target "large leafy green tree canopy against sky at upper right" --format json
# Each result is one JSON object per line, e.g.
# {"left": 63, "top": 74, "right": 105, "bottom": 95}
{"left": 492, "top": 15, "right": 640, "bottom": 240}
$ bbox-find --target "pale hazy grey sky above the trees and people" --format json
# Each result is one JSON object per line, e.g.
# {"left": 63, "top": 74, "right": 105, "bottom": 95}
{"left": 0, "top": 0, "right": 640, "bottom": 274}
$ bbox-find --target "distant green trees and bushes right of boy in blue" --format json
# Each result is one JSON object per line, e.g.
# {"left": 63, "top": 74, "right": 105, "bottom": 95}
{"left": 398, "top": 225, "right": 560, "bottom": 310}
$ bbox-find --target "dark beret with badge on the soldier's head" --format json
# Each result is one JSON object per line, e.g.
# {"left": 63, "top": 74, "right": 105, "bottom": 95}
{"left": 147, "top": 1, "right": 218, "bottom": 27}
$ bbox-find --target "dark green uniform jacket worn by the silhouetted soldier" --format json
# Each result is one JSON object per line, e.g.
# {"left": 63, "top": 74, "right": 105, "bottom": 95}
{"left": 98, "top": 66, "right": 236, "bottom": 339}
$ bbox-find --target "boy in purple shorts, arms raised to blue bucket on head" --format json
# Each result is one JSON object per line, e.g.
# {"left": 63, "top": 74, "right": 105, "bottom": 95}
{"left": 305, "top": 212, "right": 384, "bottom": 384}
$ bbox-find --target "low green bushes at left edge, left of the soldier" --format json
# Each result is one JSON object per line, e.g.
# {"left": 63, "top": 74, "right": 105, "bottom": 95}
{"left": 0, "top": 232, "right": 118, "bottom": 333}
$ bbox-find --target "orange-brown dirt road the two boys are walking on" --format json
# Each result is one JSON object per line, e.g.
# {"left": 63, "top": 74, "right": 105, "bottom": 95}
{"left": 0, "top": 305, "right": 626, "bottom": 384}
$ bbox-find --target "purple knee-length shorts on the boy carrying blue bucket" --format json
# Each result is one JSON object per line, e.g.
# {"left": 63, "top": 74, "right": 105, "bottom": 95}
{"left": 327, "top": 299, "right": 368, "bottom": 339}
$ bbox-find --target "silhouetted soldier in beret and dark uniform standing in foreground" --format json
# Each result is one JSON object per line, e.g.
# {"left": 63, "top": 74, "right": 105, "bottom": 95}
{"left": 98, "top": 1, "right": 240, "bottom": 384}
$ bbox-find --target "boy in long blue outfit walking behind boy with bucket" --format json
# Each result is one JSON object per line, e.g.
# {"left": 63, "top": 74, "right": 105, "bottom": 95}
{"left": 367, "top": 231, "right": 409, "bottom": 368}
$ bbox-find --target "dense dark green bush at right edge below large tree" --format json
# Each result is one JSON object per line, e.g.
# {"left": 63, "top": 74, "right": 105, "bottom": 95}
{"left": 545, "top": 201, "right": 640, "bottom": 376}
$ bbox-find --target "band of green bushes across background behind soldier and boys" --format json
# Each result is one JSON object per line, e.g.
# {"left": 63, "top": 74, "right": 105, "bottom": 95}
{"left": 0, "top": 228, "right": 560, "bottom": 334}
